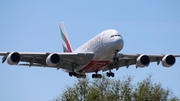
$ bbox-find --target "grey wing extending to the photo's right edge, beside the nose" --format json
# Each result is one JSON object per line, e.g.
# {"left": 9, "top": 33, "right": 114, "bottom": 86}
{"left": 102, "top": 53, "right": 180, "bottom": 71}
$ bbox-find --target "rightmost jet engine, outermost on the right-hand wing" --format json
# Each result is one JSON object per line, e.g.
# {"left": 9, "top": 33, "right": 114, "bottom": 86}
{"left": 162, "top": 55, "right": 176, "bottom": 67}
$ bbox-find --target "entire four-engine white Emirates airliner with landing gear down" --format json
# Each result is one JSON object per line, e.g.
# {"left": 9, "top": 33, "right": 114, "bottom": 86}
{"left": 0, "top": 22, "right": 180, "bottom": 78}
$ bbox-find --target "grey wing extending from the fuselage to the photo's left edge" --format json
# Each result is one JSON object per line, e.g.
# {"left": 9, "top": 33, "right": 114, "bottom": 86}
{"left": 0, "top": 52, "right": 94, "bottom": 70}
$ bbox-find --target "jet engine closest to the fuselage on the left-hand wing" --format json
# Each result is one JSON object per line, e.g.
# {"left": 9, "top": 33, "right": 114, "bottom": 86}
{"left": 46, "top": 53, "right": 61, "bottom": 66}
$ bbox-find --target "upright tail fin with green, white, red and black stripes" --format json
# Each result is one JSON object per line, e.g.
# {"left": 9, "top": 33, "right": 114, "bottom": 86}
{"left": 60, "top": 22, "right": 73, "bottom": 52}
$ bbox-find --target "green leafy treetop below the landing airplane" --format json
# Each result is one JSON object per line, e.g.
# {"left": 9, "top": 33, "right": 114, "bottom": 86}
{"left": 53, "top": 75, "right": 178, "bottom": 101}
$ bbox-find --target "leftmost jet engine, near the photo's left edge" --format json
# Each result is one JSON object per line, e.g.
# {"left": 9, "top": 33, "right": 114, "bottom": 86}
{"left": 7, "top": 52, "right": 21, "bottom": 65}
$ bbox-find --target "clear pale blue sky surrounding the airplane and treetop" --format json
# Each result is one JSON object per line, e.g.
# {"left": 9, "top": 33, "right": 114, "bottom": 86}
{"left": 0, "top": 0, "right": 180, "bottom": 101}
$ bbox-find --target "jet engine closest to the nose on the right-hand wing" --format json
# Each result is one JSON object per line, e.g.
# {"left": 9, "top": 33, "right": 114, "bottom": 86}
{"left": 136, "top": 55, "right": 150, "bottom": 67}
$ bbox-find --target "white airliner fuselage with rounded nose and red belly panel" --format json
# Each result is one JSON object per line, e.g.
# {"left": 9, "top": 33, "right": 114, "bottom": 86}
{"left": 74, "top": 29, "right": 124, "bottom": 72}
